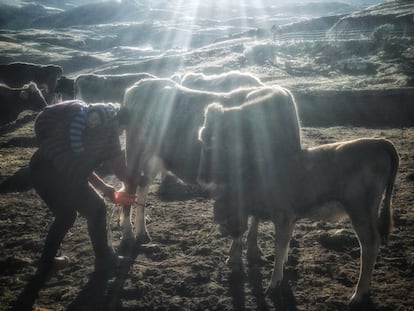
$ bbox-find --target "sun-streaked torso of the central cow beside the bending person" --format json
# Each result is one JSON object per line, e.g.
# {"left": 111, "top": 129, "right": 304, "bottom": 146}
{"left": 124, "top": 79, "right": 258, "bottom": 182}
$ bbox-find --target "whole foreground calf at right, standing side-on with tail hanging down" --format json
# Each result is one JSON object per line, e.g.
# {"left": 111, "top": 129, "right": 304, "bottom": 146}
{"left": 199, "top": 101, "right": 399, "bottom": 304}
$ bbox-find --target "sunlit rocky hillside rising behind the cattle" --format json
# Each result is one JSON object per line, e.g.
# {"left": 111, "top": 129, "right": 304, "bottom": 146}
{"left": 0, "top": 0, "right": 414, "bottom": 125}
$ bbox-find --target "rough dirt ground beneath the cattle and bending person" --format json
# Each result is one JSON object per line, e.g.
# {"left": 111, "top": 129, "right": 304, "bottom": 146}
{"left": 0, "top": 116, "right": 414, "bottom": 311}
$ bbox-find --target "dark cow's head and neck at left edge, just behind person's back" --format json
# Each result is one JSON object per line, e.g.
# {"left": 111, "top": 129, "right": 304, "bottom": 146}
{"left": 0, "top": 82, "right": 47, "bottom": 125}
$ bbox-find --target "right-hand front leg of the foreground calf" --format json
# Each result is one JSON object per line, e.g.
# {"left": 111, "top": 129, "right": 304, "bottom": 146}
{"left": 266, "top": 214, "right": 295, "bottom": 293}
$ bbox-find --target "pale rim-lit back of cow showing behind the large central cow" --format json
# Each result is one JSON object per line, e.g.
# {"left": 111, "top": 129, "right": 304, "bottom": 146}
{"left": 181, "top": 71, "right": 265, "bottom": 92}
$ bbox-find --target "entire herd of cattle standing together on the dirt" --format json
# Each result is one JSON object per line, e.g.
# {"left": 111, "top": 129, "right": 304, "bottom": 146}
{"left": 0, "top": 63, "right": 399, "bottom": 304}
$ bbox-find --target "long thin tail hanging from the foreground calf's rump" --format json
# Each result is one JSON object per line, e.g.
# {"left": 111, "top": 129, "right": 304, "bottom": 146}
{"left": 378, "top": 140, "right": 400, "bottom": 245}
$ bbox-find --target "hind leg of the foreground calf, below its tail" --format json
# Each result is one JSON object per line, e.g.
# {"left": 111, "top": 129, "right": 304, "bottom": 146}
{"left": 350, "top": 200, "right": 381, "bottom": 304}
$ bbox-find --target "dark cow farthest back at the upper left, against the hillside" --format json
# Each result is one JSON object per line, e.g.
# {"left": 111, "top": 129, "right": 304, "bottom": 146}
{"left": 0, "top": 62, "right": 63, "bottom": 105}
